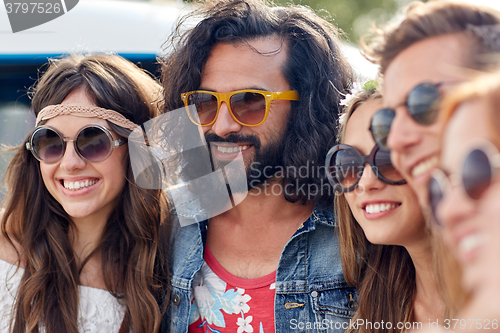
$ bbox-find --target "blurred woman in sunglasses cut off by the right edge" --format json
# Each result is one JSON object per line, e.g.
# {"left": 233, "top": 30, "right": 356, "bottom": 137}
{"left": 429, "top": 71, "right": 500, "bottom": 331}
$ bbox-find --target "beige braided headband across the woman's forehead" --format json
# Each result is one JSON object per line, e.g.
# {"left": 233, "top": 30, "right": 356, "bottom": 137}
{"left": 36, "top": 104, "right": 139, "bottom": 131}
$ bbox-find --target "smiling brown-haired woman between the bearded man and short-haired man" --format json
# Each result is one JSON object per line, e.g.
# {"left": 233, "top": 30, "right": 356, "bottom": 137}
{"left": 326, "top": 90, "right": 454, "bottom": 332}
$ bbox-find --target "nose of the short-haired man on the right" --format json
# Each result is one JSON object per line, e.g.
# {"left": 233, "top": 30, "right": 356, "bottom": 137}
{"left": 387, "top": 107, "right": 422, "bottom": 154}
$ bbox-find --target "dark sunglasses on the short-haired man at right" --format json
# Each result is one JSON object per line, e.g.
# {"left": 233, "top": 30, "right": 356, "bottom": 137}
{"left": 370, "top": 82, "right": 442, "bottom": 150}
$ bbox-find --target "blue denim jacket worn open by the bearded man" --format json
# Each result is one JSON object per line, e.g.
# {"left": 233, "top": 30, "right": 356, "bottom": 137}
{"left": 163, "top": 208, "right": 355, "bottom": 333}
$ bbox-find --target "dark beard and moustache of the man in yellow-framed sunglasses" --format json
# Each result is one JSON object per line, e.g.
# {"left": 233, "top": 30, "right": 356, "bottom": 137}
{"left": 205, "top": 133, "right": 284, "bottom": 191}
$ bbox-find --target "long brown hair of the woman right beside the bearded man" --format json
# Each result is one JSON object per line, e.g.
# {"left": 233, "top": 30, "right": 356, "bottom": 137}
{"left": 335, "top": 90, "right": 463, "bottom": 333}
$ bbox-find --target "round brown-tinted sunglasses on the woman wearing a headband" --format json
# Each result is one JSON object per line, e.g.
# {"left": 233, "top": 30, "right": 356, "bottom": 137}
{"left": 26, "top": 124, "right": 126, "bottom": 164}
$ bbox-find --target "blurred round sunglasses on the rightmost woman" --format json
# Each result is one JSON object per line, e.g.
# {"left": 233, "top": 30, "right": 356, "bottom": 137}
{"left": 429, "top": 143, "right": 500, "bottom": 224}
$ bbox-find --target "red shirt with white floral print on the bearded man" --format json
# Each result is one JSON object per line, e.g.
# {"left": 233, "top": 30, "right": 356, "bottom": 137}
{"left": 189, "top": 247, "right": 276, "bottom": 333}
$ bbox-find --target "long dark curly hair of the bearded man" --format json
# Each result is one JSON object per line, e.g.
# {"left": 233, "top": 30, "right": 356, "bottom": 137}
{"left": 162, "top": 0, "right": 353, "bottom": 205}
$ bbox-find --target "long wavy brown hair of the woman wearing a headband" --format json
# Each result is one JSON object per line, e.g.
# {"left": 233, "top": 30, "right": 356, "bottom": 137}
{"left": 1, "top": 55, "right": 170, "bottom": 333}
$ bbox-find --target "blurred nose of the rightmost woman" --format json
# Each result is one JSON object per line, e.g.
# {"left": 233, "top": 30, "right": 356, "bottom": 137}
{"left": 436, "top": 184, "right": 476, "bottom": 239}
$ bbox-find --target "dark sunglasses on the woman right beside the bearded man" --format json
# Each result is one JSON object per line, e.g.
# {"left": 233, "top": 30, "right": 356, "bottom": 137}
{"left": 325, "top": 144, "right": 406, "bottom": 192}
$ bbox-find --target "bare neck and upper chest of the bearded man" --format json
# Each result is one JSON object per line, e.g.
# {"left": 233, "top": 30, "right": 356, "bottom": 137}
{"left": 207, "top": 179, "right": 314, "bottom": 279}
